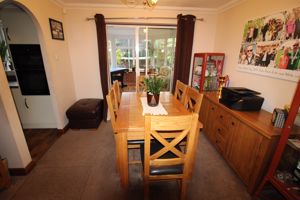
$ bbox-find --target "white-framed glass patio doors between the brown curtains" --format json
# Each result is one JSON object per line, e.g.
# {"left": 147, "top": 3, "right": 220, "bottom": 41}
{"left": 107, "top": 25, "right": 176, "bottom": 90}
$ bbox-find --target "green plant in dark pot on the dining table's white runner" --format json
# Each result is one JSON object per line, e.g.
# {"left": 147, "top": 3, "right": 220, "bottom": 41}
{"left": 144, "top": 76, "right": 164, "bottom": 107}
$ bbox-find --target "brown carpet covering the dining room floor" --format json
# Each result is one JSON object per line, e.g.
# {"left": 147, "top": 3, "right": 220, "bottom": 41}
{"left": 0, "top": 122, "right": 250, "bottom": 200}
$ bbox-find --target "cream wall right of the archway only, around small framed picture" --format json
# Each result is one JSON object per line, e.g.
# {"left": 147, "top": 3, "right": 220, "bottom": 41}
{"left": 17, "top": 0, "right": 76, "bottom": 129}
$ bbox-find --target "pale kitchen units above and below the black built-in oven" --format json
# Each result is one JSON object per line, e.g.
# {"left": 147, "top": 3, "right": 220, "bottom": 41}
{"left": 0, "top": 7, "right": 56, "bottom": 128}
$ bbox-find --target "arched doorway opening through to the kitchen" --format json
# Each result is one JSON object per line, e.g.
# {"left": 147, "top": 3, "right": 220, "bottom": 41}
{"left": 0, "top": 3, "right": 58, "bottom": 162}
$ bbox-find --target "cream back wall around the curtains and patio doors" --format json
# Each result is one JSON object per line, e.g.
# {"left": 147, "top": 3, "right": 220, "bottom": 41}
{"left": 65, "top": 5, "right": 217, "bottom": 99}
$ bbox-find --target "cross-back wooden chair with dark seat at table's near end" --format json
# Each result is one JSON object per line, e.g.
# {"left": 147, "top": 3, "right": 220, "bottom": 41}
{"left": 143, "top": 113, "right": 199, "bottom": 200}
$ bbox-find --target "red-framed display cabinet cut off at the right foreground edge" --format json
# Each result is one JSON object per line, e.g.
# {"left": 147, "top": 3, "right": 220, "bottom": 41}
{"left": 253, "top": 81, "right": 300, "bottom": 200}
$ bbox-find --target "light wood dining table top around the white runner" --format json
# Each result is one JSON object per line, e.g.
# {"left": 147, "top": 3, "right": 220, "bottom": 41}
{"left": 116, "top": 92, "right": 190, "bottom": 140}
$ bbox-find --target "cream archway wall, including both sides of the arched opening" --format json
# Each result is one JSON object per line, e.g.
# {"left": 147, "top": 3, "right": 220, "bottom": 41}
{"left": 0, "top": 0, "right": 76, "bottom": 168}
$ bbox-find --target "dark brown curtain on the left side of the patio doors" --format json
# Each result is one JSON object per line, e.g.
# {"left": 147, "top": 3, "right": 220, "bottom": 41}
{"left": 95, "top": 14, "right": 109, "bottom": 121}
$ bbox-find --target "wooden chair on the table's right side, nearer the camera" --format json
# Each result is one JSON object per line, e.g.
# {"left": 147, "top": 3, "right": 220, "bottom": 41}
{"left": 183, "top": 86, "right": 203, "bottom": 114}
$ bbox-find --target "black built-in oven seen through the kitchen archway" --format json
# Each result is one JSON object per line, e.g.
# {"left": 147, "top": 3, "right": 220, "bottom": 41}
{"left": 9, "top": 44, "right": 50, "bottom": 95}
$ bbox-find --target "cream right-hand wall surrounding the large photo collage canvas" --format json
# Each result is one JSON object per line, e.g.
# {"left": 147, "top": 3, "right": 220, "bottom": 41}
{"left": 215, "top": 0, "right": 300, "bottom": 112}
